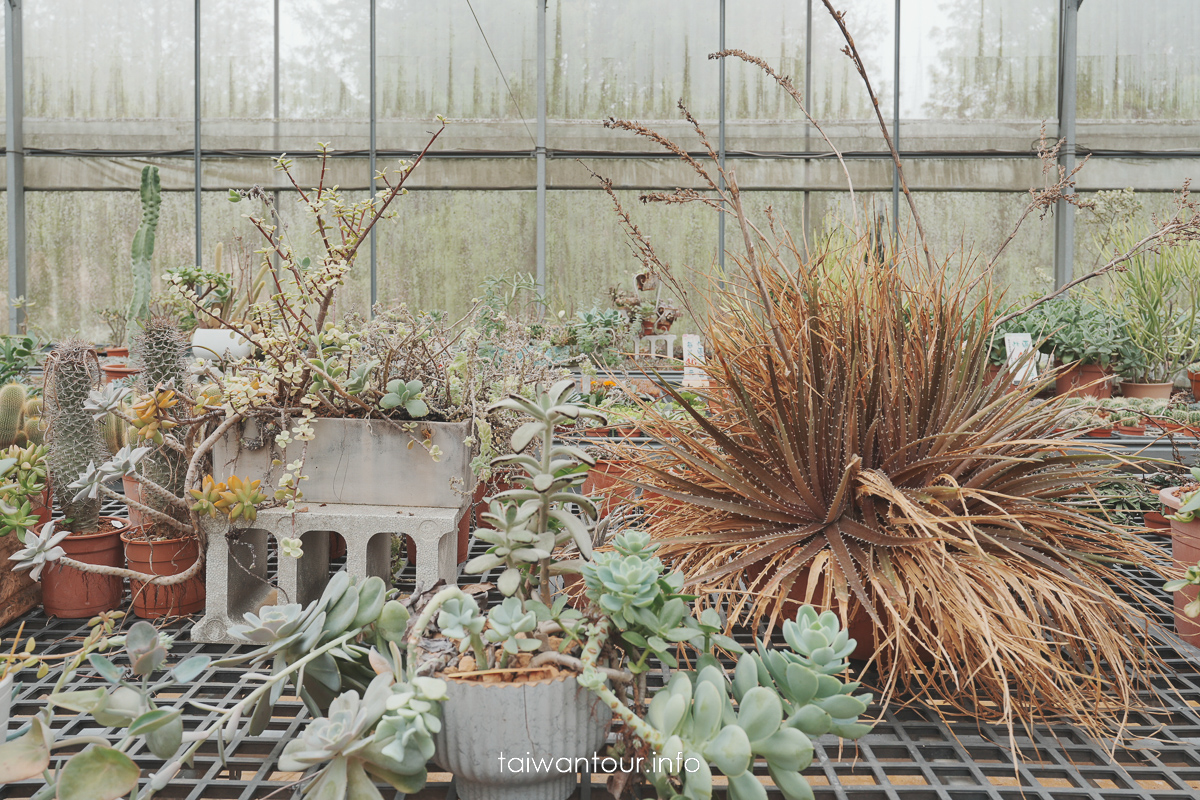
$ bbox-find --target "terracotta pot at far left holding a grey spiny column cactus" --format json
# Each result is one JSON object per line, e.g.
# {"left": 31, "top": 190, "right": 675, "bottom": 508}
{"left": 34, "top": 517, "right": 128, "bottom": 619}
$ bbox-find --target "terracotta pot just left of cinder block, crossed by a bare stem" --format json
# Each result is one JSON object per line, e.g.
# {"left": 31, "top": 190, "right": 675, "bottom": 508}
{"left": 121, "top": 530, "right": 204, "bottom": 619}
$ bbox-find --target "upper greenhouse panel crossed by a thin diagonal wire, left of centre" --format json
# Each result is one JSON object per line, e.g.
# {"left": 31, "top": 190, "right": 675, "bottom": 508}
{"left": 376, "top": 0, "right": 538, "bottom": 152}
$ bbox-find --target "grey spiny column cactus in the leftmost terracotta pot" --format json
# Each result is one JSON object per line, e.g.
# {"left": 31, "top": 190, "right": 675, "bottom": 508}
{"left": 43, "top": 338, "right": 108, "bottom": 533}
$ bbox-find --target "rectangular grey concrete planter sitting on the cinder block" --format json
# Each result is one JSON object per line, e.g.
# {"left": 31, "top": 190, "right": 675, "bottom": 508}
{"left": 212, "top": 419, "right": 475, "bottom": 509}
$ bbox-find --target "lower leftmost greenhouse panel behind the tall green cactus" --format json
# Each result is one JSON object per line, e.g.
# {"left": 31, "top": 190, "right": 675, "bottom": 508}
{"left": 25, "top": 191, "right": 196, "bottom": 342}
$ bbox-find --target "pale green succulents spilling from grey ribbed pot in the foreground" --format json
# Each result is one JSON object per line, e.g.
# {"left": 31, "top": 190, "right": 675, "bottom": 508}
{"left": 0, "top": 384, "right": 871, "bottom": 800}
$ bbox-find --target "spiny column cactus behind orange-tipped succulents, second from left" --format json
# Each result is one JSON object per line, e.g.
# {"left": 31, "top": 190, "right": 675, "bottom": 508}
{"left": 130, "top": 317, "right": 191, "bottom": 522}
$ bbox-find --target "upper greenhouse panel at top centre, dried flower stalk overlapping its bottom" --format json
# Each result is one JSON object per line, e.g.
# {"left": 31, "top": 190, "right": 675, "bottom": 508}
{"left": 546, "top": 0, "right": 720, "bottom": 150}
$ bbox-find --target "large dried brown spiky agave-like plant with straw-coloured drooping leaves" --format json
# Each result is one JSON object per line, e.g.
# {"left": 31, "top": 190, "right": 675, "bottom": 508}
{"left": 585, "top": 32, "right": 1195, "bottom": 744}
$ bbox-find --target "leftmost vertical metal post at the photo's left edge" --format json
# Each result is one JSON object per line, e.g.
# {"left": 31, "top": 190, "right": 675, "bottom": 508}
{"left": 4, "top": 0, "right": 25, "bottom": 333}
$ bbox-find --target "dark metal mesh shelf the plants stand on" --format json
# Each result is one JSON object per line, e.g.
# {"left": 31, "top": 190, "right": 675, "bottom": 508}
{"left": 7, "top": 510, "right": 1200, "bottom": 800}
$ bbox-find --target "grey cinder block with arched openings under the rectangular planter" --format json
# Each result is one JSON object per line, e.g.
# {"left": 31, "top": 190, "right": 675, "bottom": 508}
{"left": 192, "top": 503, "right": 470, "bottom": 642}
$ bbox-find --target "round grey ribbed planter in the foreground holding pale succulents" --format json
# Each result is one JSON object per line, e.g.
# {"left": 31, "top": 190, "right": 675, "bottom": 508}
{"left": 433, "top": 675, "right": 612, "bottom": 800}
